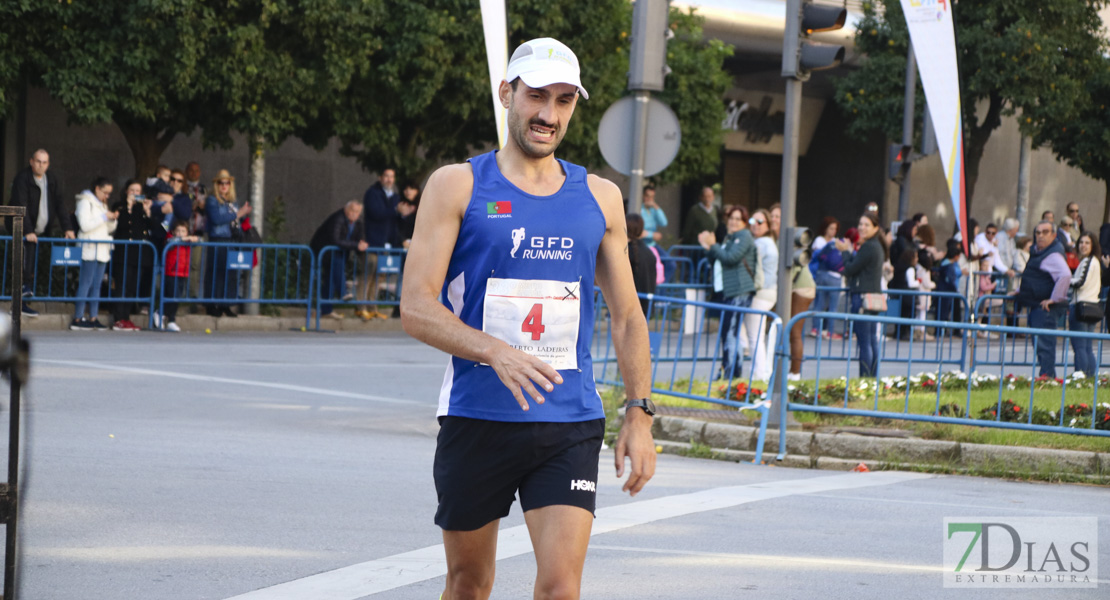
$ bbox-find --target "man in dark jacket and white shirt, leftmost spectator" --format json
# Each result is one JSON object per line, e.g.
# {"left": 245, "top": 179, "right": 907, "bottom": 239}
{"left": 6, "top": 149, "right": 73, "bottom": 317}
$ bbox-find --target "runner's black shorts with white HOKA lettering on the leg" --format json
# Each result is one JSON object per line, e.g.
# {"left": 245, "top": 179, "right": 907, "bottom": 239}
{"left": 433, "top": 417, "right": 605, "bottom": 531}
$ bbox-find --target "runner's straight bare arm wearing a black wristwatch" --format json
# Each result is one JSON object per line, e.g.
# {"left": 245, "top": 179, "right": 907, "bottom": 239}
{"left": 588, "top": 175, "right": 655, "bottom": 496}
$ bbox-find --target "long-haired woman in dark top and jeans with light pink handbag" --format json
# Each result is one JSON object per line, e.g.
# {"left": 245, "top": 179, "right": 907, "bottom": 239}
{"left": 836, "top": 213, "right": 887, "bottom": 377}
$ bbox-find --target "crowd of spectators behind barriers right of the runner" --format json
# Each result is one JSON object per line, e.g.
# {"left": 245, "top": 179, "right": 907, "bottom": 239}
{"left": 628, "top": 182, "right": 1110, "bottom": 379}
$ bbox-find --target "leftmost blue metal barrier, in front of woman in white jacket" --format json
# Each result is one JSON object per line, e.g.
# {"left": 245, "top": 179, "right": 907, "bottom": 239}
{"left": 0, "top": 235, "right": 159, "bottom": 323}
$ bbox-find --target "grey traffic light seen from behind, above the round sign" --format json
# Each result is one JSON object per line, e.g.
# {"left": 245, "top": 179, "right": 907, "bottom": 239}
{"left": 628, "top": 0, "right": 675, "bottom": 92}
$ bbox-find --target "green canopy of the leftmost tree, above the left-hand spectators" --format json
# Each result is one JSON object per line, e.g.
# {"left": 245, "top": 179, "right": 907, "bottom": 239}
{"left": 16, "top": 0, "right": 384, "bottom": 174}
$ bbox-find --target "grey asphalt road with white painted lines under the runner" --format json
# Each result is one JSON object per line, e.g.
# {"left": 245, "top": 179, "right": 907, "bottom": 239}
{"left": 3, "top": 333, "right": 1110, "bottom": 600}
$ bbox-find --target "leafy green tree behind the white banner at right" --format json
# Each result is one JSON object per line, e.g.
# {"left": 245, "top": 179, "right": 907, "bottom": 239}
{"left": 835, "top": 0, "right": 1106, "bottom": 205}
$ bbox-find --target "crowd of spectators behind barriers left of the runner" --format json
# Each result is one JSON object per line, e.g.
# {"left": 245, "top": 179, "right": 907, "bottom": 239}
{"left": 6, "top": 150, "right": 420, "bottom": 332}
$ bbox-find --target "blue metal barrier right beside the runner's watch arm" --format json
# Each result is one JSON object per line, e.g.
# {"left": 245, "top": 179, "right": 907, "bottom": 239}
{"left": 593, "top": 294, "right": 783, "bottom": 464}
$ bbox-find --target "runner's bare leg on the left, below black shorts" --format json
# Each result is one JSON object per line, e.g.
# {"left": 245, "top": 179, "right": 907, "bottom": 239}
{"left": 443, "top": 519, "right": 501, "bottom": 600}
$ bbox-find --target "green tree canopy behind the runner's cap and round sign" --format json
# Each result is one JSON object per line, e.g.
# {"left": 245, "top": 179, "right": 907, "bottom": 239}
{"left": 330, "top": 0, "right": 731, "bottom": 181}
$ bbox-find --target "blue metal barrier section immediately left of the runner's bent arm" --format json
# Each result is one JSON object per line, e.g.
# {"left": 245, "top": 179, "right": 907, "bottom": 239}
{"left": 314, "top": 246, "right": 408, "bottom": 330}
